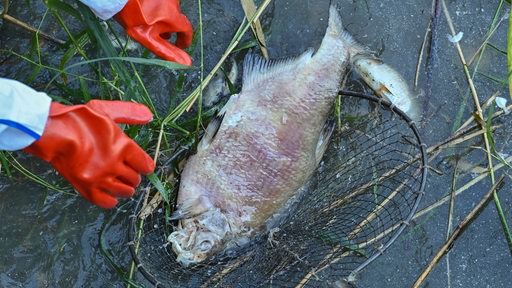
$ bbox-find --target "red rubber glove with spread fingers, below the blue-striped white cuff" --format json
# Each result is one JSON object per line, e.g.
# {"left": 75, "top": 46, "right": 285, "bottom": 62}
{"left": 23, "top": 100, "right": 155, "bottom": 208}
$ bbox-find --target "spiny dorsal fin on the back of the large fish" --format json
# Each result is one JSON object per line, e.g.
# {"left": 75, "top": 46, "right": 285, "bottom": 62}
{"left": 242, "top": 48, "right": 314, "bottom": 90}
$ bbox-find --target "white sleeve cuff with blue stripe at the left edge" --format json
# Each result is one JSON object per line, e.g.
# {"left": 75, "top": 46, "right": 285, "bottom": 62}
{"left": 0, "top": 78, "right": 52, "bottom": 151}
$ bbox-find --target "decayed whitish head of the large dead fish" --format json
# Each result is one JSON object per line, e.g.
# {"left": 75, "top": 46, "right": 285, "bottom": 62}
{"left": 168, "top": 208, "right": 231, "bottom": 267}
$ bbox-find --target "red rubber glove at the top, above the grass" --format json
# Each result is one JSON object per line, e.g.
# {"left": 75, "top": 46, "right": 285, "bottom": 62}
{"left": 114, "top": 0, "right": 193, "bottom": 65}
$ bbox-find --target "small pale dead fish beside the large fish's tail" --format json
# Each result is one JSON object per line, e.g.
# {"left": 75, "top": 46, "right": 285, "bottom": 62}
{"left": 351, "top": 54, "right": 421, "bottom": 122}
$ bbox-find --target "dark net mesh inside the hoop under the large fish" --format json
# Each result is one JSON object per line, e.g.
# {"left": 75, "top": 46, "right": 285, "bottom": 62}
{"left": 129, "top": 92, "right": 426, "bottom": 287}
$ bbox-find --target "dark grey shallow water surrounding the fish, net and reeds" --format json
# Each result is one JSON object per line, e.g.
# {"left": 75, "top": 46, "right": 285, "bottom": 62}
{"left": 0, "top": 0, "right": 512, "bottom": 287}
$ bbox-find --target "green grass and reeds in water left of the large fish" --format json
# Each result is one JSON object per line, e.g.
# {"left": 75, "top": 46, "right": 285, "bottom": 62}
{"left": 0, "top": 0, "right": 270, "bottom": 286}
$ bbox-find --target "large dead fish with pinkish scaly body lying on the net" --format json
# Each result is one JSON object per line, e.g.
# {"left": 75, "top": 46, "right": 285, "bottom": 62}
{"left": 168, "top": 7, "right": 357, "bottom": 266}
